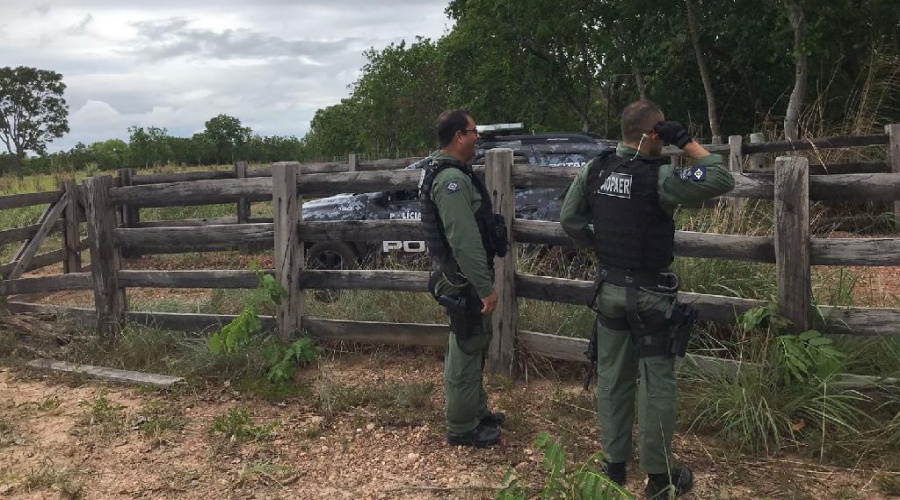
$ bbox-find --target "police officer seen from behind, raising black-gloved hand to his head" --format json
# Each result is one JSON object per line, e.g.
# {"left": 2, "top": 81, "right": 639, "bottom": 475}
{"left": 560, "top": 100, "right": 734, "bottom": 498}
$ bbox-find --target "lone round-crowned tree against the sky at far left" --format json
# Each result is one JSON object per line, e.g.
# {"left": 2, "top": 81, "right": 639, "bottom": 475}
{"left": 0, "top": 66, "right": 69, "bottom": 175}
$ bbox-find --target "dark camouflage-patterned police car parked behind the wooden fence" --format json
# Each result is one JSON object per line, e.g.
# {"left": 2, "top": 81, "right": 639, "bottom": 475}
{"left": 303, "top": 123, "right": 616, "bottom": 269}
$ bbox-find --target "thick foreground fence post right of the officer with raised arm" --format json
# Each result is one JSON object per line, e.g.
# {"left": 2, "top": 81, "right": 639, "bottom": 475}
{"left": 775, "top": 156, "right": 812, "bottom": 332}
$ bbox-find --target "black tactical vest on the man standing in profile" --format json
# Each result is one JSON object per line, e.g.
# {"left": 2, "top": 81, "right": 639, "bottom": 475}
{"left": 419, "top": 159, "right": 496, "bottom": 268}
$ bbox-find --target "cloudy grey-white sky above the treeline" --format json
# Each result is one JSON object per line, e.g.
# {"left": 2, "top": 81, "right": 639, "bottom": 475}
{"left": 0, "top": 0, "right": 450, "bottom": 151}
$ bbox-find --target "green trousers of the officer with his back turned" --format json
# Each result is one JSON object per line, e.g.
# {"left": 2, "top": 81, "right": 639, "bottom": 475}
{"left": 596, "top": 283, "right": 678, "bottom": 474}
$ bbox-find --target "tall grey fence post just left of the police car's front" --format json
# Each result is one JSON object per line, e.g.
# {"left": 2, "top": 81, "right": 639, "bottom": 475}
{"left": 272, "top": 162, "right": 305, "bottom": 342}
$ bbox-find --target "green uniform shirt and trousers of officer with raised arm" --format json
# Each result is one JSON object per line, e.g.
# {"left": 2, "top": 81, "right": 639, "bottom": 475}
{"left": 560, "top": 144, "right": 734, "bottom": 474}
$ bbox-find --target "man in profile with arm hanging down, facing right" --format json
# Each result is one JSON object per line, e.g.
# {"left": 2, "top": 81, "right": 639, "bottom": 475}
{"left": 419, "top": 109, "right": 507, "bottom": 447}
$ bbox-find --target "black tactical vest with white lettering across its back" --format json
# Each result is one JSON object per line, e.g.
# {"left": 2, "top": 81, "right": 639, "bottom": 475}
{"left": 587, "top": 152, "right": 675, "bottom": 269}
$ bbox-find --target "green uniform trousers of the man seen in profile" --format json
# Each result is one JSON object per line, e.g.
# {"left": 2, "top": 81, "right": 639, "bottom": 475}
{"left": 444, "top": 316, "right": 491, "bottom": 434}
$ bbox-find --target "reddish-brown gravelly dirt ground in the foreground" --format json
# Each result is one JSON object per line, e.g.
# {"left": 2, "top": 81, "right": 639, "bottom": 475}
{"left": 0, "top": 351, "right": 890, "bottom": 500}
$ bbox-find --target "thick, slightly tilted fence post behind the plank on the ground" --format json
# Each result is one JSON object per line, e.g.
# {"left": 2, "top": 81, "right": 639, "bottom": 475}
{"left": 84, "top": 175, "right": 125, "bottom": 341}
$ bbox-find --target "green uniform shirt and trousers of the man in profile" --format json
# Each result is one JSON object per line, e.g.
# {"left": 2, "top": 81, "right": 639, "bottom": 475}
{"left": 431, "top": 152, "right": 494, "bottom": 434}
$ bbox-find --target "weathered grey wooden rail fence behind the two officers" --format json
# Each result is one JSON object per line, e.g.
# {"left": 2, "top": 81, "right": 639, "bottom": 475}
{"left": 0, "top": 125, "right": 900, "bottom": 373}
